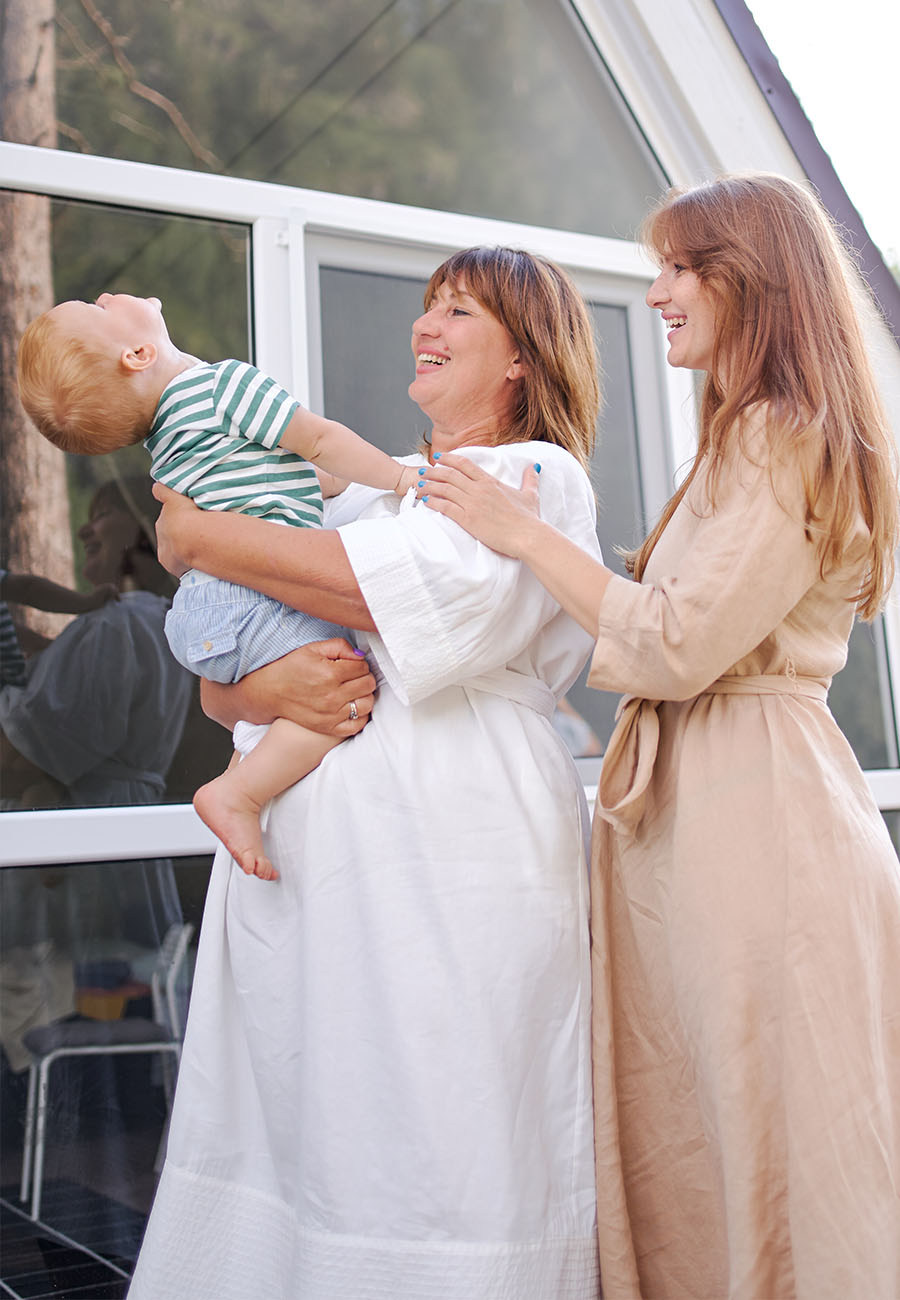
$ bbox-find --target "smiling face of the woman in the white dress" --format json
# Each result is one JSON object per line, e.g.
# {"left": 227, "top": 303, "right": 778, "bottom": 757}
{"left": 410, "top": 281, "right": 522, "bottom": 449}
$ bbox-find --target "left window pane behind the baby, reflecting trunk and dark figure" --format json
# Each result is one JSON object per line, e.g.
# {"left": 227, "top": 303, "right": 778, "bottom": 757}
{"left": 0, "top": 194, "right": 243, "bottom": 809}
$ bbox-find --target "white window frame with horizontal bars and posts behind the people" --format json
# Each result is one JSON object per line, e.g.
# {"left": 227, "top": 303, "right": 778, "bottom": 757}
{"left": 0, "top": 142, "right": 900, "bottom": 866}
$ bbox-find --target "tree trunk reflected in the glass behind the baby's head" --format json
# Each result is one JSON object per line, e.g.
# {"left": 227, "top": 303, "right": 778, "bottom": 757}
{"left": 0, "top": 0, "right": 74, "bottom": 633}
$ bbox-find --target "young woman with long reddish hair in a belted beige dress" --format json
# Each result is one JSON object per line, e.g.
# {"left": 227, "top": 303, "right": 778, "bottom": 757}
{"left": 424, "top": 174, "right": 900, "bottom": 1300}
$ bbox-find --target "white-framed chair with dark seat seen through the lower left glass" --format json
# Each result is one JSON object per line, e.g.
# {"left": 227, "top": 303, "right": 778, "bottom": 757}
{"left": 20, "top": 924, "right": 194, "bottom": 1219}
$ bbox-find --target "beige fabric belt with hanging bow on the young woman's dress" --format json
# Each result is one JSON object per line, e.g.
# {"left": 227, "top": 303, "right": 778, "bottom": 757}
{"left": 596, "top": 673, "right": 828, "bottom": 835}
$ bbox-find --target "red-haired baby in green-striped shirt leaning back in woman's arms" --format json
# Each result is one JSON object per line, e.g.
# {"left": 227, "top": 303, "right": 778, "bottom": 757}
{"left": 18, "top": 294, "right": 416, "bottom": 880}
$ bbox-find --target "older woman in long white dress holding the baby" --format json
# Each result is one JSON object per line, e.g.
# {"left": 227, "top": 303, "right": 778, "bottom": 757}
{"left": 131, "top": 250, "right": 600, "bottom": 1300}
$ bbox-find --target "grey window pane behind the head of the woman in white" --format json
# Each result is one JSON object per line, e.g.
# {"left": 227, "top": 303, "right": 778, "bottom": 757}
{"left": 320, "top": 267, "right": 642, "bottom": 757}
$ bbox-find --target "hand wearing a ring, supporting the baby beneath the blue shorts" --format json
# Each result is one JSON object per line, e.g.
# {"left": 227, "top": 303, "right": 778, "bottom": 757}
{"left": 200, "top": 637, "right": 376, "bottom": 736}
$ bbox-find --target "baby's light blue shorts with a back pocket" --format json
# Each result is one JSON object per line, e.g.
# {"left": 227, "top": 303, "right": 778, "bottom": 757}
{"left": 165, "top": 569, "right": 347, "bottom": 683}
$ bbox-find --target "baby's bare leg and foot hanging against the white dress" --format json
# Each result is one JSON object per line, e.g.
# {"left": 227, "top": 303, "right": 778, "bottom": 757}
{"left": 194, "top": 718, "right": 341, "bottom": 880}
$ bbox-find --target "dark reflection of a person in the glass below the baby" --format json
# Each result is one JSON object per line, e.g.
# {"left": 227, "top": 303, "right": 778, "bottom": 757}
{"left": 0, "top": 477, "right": 191, "bottom": 1069}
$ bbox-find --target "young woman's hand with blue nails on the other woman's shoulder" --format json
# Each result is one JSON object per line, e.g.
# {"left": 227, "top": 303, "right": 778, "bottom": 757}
{"left": 417, "top": 452, "right": 541, "bottom": 559}
